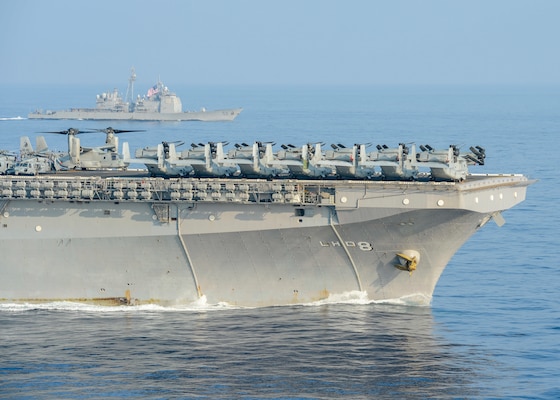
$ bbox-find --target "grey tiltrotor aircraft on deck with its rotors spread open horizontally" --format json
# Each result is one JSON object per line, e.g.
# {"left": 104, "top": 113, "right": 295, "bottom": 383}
{"left": 46, "top": 127, "right": 140, "bottom": 170}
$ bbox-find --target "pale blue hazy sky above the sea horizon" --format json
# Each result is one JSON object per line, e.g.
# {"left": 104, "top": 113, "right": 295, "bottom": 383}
{"left": 0, "top": 0, "right": 560, "bottom": 85}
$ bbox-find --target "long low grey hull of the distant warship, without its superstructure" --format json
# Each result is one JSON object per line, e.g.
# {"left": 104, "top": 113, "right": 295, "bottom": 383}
{"left": 28, "top": 108, "right": 242, "bottom": 122}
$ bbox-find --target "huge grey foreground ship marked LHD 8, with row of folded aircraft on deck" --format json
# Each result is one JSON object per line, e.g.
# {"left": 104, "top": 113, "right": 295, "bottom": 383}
{"left": 0, "top": 133, "right": 532, "bottom": 307}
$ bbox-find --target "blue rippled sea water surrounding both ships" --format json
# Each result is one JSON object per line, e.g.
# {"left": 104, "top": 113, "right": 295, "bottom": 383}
{"left": 0, "top": 85, "right": 560, "bottom": 399}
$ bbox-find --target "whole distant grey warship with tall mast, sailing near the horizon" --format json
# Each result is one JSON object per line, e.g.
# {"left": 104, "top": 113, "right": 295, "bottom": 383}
{"left": 28, "top": 68, "right": 242, "bottom": 121}
